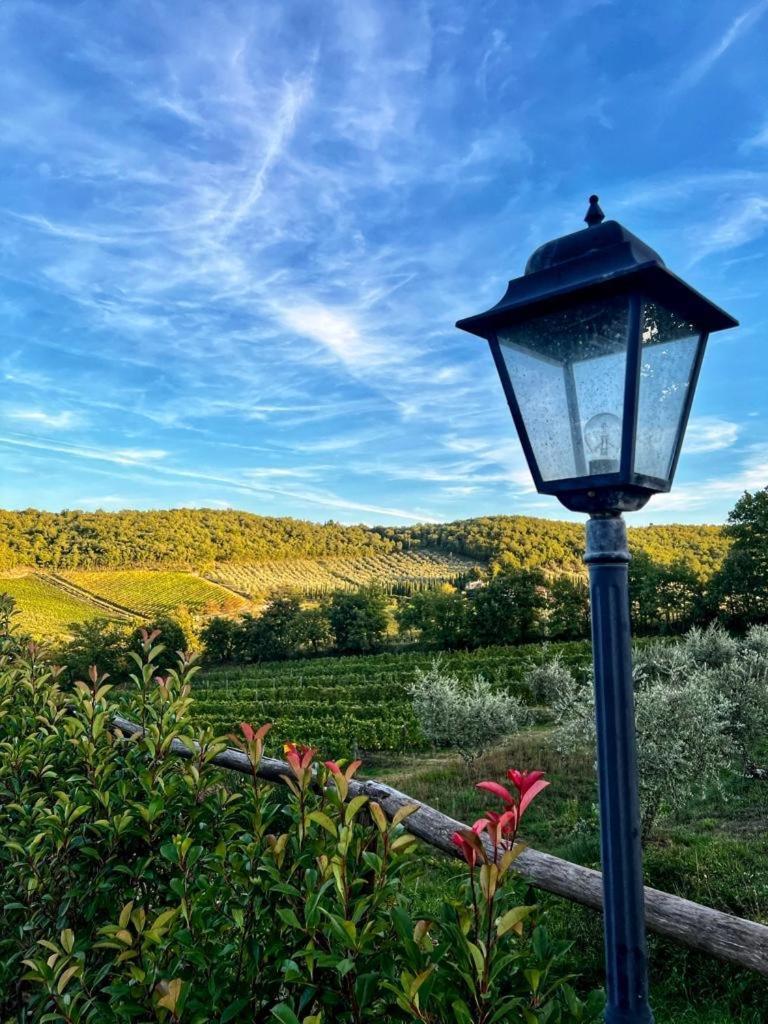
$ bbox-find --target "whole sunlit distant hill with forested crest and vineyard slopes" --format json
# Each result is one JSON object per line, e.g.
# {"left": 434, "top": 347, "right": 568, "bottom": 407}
{"left": 0, "top": 509, "right": 729, "bottom": 636}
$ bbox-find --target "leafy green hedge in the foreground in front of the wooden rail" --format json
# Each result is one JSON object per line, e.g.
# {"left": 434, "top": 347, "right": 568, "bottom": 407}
{"left": 0, "top": 614, "right": 600, "bottom": 1024}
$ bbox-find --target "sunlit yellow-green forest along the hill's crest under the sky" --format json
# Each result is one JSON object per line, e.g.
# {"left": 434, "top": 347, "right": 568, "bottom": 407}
{"left": 0, "top": 509, "right": 728, "bottom": 579}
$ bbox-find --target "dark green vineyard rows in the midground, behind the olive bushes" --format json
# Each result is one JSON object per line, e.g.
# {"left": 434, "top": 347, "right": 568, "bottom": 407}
{"left": 194, "top": 642, "right": 590, "bottom": 756}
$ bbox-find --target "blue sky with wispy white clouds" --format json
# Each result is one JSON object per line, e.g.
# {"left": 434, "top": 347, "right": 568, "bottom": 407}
{"left": 0, "top": 0, "right": 768, "bottom": 523}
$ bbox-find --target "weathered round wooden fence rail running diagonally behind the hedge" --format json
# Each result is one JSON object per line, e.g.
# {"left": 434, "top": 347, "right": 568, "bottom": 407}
{"left": 113, "top": 718, "right": 768, "bottom": 977}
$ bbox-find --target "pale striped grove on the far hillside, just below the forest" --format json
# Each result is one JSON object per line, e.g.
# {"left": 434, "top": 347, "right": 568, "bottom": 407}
{"left": 208, "top": 551, "right": 477, "bottom": 598}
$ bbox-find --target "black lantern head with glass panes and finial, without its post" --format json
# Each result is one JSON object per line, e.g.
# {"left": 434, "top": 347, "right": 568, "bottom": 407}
{"left": 457, "top": 196, "right": 737, "bottom": 514}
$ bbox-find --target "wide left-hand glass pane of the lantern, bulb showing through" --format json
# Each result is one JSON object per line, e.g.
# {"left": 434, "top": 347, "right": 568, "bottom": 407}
{"left": 498, "top": 296, "right": 629, "bottom": 481}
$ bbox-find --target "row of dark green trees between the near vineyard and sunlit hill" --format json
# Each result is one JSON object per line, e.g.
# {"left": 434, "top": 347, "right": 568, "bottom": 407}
{"left": 185, "top": 488, "right": 768, "bottom": 662}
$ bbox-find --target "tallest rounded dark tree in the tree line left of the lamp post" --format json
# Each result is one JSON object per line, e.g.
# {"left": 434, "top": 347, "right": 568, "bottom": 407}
{"left": 472, "top": 567, "right": 546, "bottom": 646}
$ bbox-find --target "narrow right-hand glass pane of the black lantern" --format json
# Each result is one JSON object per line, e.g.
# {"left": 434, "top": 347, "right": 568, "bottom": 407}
{"left": 635, "top": 300, "right": 702, "bottom": 482}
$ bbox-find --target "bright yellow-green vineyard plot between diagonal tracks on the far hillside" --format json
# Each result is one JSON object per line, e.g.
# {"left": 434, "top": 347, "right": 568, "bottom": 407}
{"left": 61, "top": 569, "right": 246, "bottom": 615}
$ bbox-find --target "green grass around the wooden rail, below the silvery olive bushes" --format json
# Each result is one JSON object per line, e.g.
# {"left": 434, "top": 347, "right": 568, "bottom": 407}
{"left": 365, "top": 729, "right": 768, "bottom": 1024}
